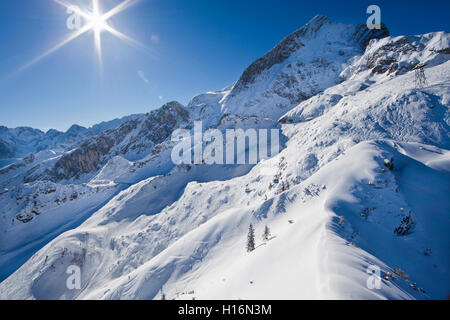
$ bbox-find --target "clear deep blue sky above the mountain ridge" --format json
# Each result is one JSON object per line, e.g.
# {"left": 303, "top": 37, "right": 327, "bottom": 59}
{"left": 0, "top": 0, "right": 450, "bottom": 130}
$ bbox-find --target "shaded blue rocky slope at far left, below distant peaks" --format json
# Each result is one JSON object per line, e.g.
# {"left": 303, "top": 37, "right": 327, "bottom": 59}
{"left": 0, "top": 103, "right": 188, "bottom": 279}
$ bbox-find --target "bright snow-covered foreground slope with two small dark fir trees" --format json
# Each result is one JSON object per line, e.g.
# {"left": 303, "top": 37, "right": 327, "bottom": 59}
{"left": 0, "top": 141, "right": 450, "bottom": 299}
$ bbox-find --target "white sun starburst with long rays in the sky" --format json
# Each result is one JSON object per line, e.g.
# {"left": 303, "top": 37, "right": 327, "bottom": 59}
{"left": 17, "top": 0, "right": 149, "bottom": 72}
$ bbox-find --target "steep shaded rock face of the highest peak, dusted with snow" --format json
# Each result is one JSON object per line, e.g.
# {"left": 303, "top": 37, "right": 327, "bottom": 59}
{"left": 221, "top": 15, "right": 389, "bottom": 120}
